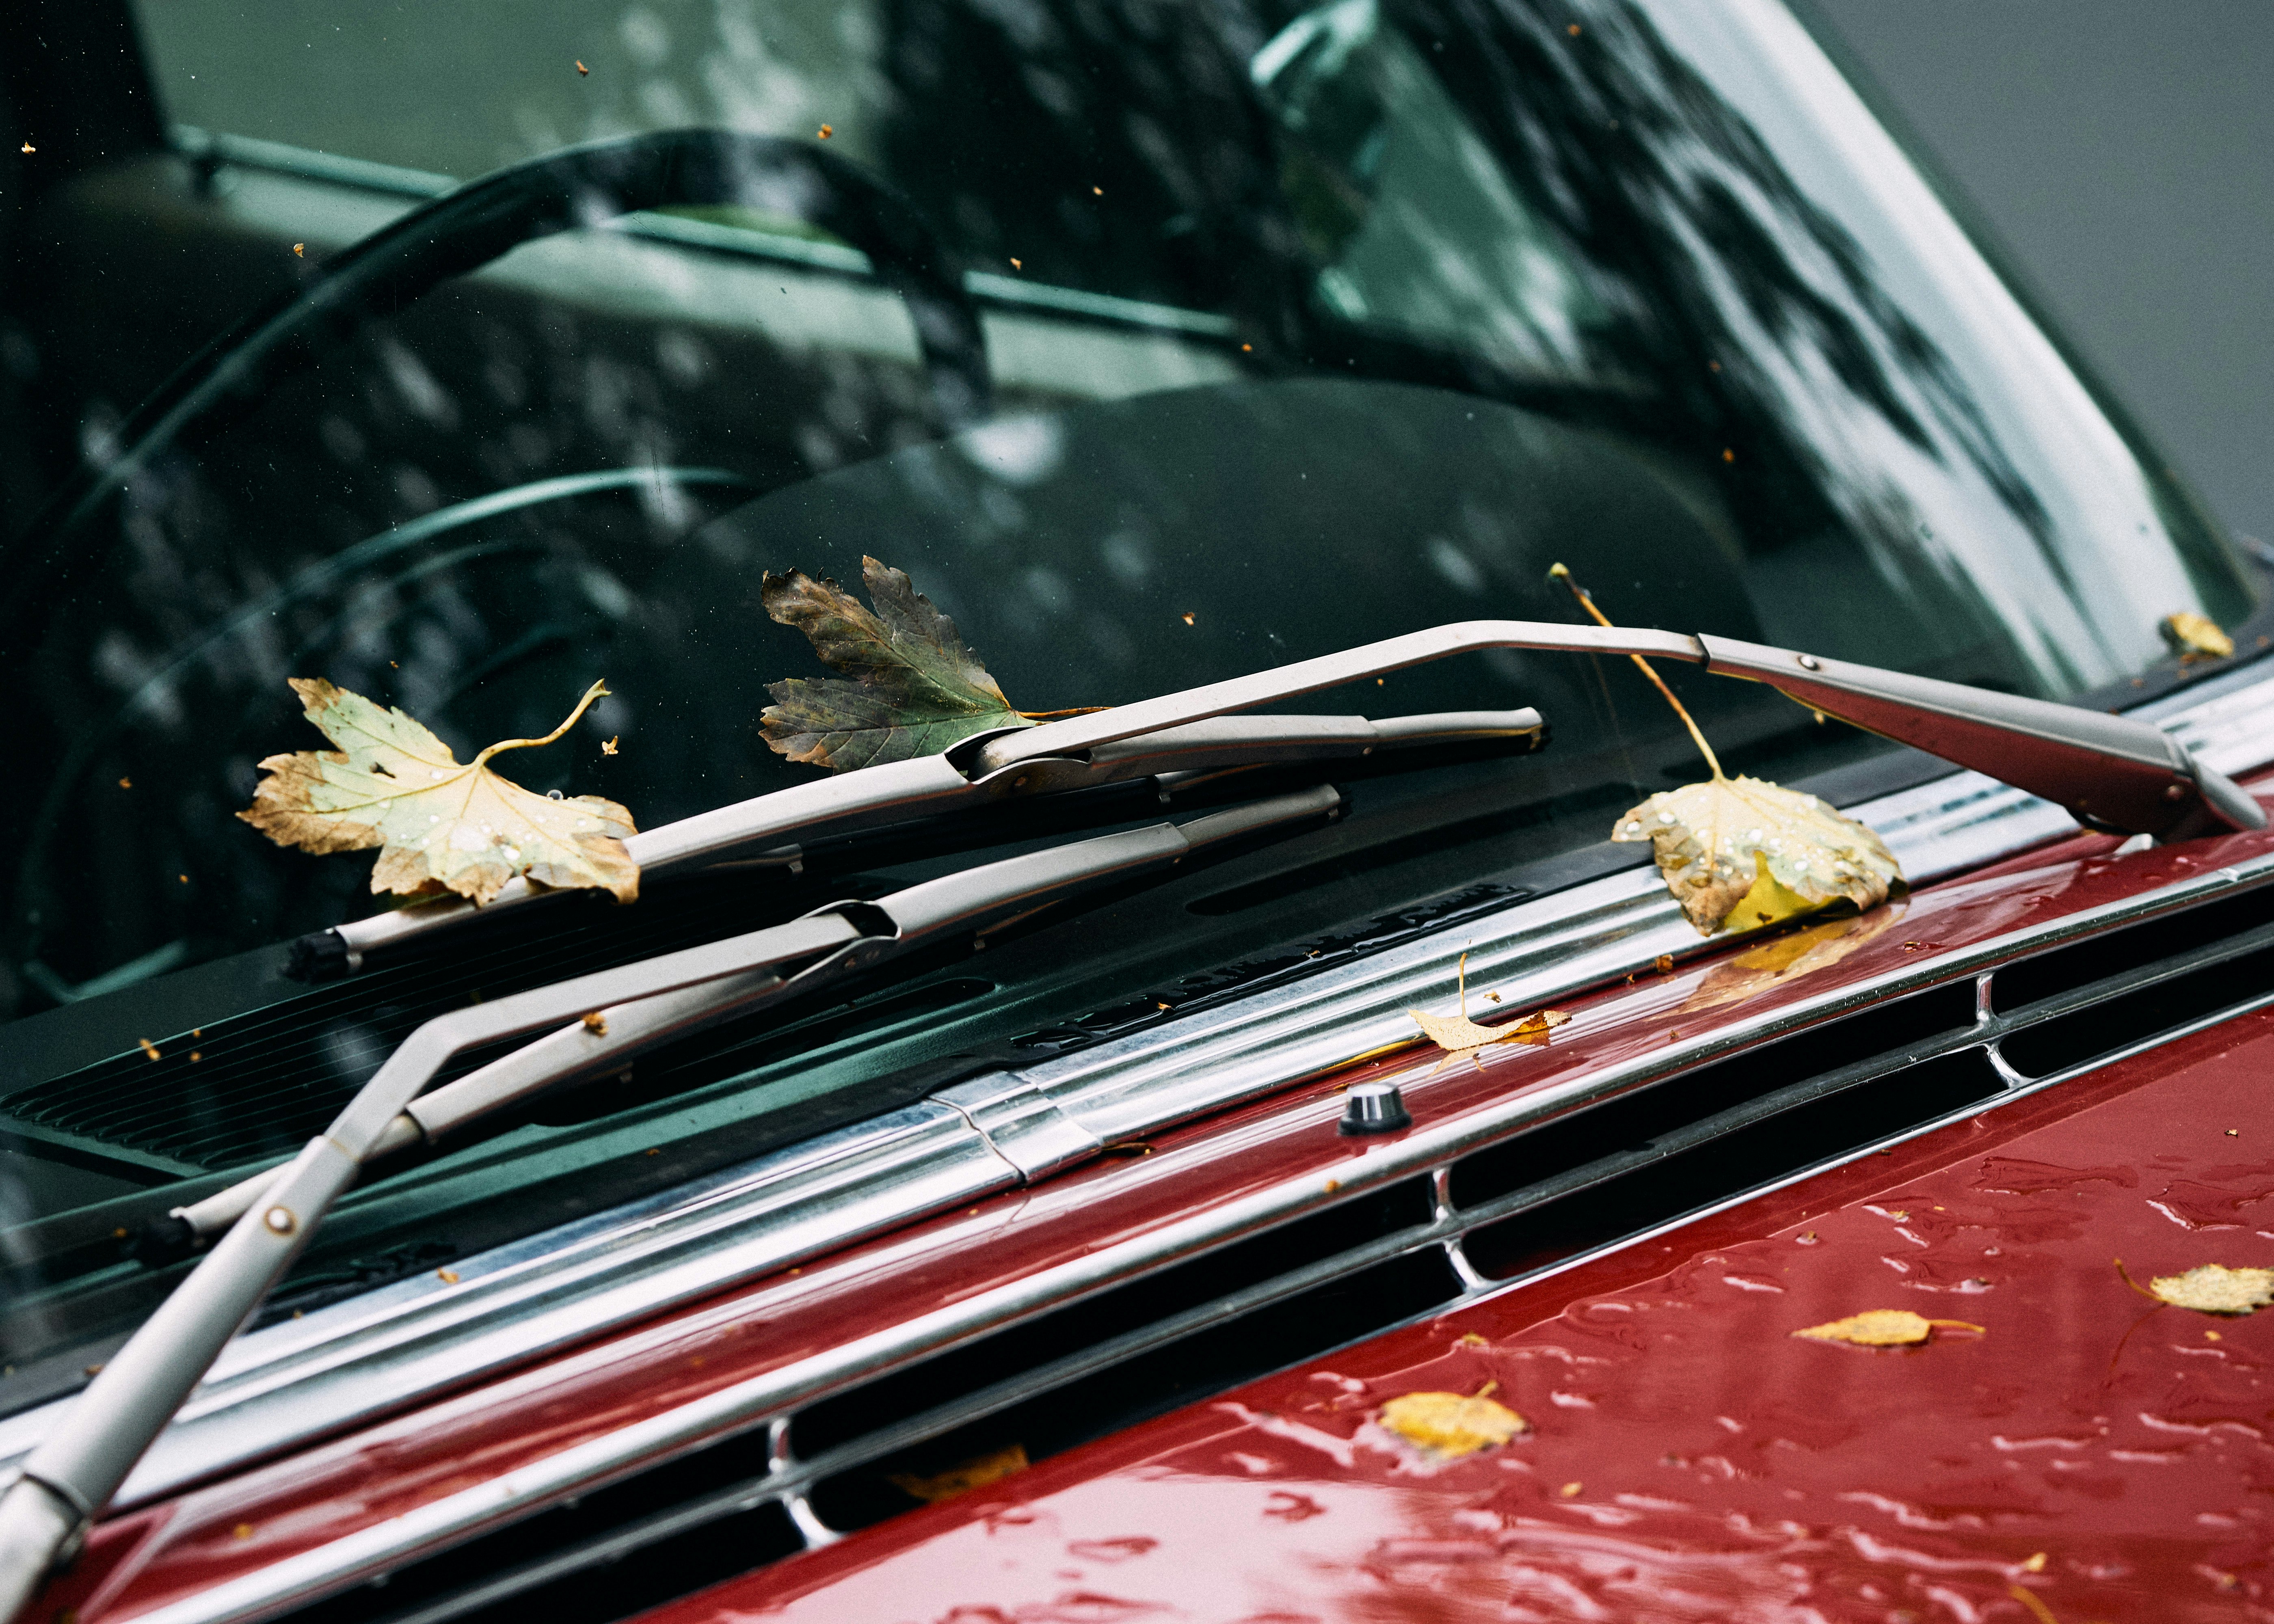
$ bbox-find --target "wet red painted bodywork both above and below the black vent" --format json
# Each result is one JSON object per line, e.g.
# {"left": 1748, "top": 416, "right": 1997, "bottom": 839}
{"left": 31, "top": 805, "right": 2274, "bottom": 1624}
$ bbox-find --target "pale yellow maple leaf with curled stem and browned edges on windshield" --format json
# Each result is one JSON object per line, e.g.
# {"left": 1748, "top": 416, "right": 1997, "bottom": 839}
{"left": 236, "top": 678, "right": 639, "bottom": 903}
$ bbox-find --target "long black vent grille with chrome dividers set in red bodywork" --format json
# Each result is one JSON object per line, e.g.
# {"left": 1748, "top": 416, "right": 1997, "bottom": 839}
{"left": 270, "top": 864, "right": 2274, "bottom": 1624}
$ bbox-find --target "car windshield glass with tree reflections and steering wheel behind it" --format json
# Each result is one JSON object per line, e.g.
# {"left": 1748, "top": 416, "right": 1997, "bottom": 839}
{"left": 0, "top": 0, "right": 2265, "bottom": 1392}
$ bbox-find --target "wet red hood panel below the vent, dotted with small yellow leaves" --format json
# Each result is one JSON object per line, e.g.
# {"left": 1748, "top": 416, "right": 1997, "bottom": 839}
{"left": 651, "top": 1015, "right": 2274, "bottom": 1624}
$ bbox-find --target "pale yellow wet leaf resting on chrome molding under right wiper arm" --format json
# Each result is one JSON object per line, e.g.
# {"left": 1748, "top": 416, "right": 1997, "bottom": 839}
{"left": 1610, "top": 775, "right": 1903, "bottom": 935}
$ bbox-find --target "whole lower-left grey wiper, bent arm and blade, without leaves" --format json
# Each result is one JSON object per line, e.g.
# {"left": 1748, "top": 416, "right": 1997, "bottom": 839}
{"left": 0, "top": 785, "right": 1342, "bottom": 1622}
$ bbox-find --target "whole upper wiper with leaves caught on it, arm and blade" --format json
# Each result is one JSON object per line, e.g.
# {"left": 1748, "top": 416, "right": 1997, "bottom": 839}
{"left": 318, "top": 621, "right": 2265, "bottom": 969}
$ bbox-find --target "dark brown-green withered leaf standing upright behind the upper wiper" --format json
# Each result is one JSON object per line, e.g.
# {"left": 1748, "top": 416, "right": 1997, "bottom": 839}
{"left": 759, "top": 557, "right": 1032, "bottom": 773}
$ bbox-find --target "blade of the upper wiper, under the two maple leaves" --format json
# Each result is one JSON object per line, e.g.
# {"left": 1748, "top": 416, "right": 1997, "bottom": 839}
{"left": 296, "top": 707, "right": 1546, "bottom": 978}
